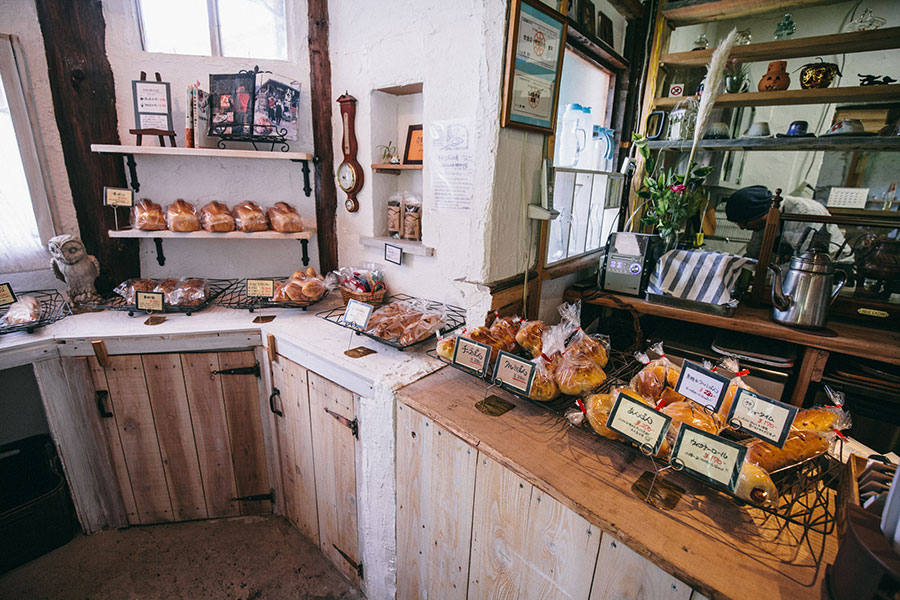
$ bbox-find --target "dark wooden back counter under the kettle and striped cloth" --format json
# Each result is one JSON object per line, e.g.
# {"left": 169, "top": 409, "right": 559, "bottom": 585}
{"left": 565, "top": 289, "right": 900, "bottom": 365}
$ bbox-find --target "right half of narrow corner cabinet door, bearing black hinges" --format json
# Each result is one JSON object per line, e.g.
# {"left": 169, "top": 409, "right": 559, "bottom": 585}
{"left": 308, "top": 371, "right": 360, "bottom": 585}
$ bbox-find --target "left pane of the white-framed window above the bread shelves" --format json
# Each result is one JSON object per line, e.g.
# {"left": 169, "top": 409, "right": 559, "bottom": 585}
{"left": 138, "top": 0, "right": 212, "bottom": 56}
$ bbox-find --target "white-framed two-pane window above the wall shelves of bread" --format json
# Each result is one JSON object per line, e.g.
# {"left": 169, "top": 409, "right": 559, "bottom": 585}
{"left": 137, "top": 0, "right": 287, "bottom": 60}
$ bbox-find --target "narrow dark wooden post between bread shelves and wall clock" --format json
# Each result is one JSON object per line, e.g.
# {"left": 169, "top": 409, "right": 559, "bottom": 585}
{"left": 307, "top": 0, "right": 339, "bottom": 273}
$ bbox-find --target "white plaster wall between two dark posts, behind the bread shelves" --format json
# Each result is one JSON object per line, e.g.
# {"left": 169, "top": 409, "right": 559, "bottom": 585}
{"left": 97, "top": 0, "right": 319, "bottom": 277}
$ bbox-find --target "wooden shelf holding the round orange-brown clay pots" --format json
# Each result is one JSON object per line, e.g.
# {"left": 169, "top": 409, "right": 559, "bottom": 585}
{"left": 653, "top": 84, "right": 900, "bottom": 109}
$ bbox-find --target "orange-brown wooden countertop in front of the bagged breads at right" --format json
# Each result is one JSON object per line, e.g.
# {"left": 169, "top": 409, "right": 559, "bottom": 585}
{"left": 397, "top": 367, "right": 837, "bottom": 600}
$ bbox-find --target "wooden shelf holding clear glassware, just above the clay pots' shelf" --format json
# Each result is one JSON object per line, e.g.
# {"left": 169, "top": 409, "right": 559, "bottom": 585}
{"left": 659, "top": 27, "right": 900, "bottom": 67}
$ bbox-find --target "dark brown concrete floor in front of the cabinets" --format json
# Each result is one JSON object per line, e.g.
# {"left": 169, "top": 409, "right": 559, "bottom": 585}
{"left": 0, "top": 516, "right": 363, "bottom": 600}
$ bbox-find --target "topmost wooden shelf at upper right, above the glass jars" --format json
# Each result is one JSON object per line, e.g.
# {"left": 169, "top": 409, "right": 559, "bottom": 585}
{"left": 662, "top": 0, "right": 844, "bottom": 25}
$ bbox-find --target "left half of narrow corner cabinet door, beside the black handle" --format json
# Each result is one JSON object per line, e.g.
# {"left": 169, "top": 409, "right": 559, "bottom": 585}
{"left": 272, "top": 356, "right": 319, "bottom": 545}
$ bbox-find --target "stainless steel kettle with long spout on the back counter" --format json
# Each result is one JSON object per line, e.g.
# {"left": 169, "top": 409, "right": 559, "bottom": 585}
{"left": 769, "top": 249, "right": 847, "bottom": 329}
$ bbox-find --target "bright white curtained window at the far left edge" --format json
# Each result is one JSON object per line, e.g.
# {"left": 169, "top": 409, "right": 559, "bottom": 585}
{"left": 0, "top": 60, "right": 49, "bottom": 273}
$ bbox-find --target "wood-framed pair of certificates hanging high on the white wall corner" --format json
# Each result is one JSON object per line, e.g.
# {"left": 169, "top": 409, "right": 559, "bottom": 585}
{"left": 500, "top": 0, "right": 566, "bottom": 133}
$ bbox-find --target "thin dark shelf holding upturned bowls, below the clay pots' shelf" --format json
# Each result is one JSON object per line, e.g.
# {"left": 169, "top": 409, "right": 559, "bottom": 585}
{"left": 647, "top": 136, "right": 900, "bottom": 152}
